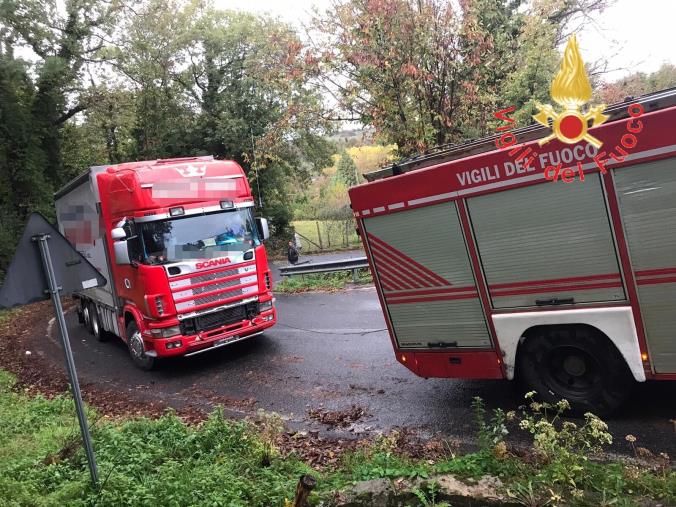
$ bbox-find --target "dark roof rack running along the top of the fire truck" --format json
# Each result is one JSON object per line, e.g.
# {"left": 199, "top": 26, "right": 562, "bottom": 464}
{"left": 364, "top": 87, "right": 676, "bottom": 182}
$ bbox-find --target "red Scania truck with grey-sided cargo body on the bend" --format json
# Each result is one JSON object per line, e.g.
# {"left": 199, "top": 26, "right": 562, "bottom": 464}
{"left": 55, "top": 157, "right": 276, "bottom": 369}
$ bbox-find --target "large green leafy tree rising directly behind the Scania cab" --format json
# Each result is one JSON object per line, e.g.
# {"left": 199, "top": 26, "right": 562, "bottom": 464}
{"left": 109, "top": 0, "right": 334, "bottom": 235}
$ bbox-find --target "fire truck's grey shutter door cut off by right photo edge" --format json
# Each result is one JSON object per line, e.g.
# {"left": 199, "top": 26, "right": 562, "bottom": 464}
{"left": 613, "top": 158, "right": 676, "bottom": 373}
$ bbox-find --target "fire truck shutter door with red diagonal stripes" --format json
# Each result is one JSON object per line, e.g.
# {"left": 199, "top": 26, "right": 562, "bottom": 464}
{"left": 364, "top": 202, "right": 491, "bottom": 349}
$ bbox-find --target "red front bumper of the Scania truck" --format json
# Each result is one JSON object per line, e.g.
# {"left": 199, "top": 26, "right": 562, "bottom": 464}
{"left": 144, "top": 307, "right": 277, "bottom": 357}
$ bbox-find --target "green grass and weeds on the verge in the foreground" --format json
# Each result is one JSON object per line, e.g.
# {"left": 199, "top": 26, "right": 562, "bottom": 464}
{"left": 0, "top": 370, "right": 676, "bottom": 507}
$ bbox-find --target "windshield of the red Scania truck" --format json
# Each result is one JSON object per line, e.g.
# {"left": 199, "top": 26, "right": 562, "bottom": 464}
{"left": 139, "top": 209, "right": 260, "bottom": 264}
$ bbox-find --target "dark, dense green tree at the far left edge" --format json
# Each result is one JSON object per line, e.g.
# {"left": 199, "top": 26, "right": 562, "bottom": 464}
{"left": 0, "top": 0, "right": 119, "bottom": 271}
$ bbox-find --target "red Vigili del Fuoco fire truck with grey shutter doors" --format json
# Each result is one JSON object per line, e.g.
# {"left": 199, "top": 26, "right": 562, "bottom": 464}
{"left": 349, "top": 90, "right": 676, "bottom": 414}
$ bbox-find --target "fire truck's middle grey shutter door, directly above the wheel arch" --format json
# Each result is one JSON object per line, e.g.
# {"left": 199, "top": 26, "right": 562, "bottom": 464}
{"left": 467, "top": 175, "right": 626, "bottom": 308}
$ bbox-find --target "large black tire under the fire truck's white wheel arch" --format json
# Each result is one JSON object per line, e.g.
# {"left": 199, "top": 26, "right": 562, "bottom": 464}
{"left": 517, "top": 325, "right": 634, "bottom": 417}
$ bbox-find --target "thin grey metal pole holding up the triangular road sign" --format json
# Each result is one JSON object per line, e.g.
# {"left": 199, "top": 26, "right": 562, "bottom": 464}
{"left": 33, "top": 234, "right": 99, "bottom": 486}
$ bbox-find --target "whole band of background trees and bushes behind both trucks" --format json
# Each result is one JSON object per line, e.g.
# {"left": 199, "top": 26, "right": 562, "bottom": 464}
{"left": 5, "top": 0, "right": 676, "bottom": 276}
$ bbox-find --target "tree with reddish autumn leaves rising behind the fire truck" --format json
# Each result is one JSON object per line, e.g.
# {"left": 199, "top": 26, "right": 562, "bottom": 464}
{"left": 313, "top": 0, "right": 606, "bottom": 155}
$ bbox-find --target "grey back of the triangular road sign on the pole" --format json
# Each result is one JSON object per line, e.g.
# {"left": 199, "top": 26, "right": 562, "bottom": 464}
{"left": 0, "top": 213, "right": 106, "bottom": 308}
